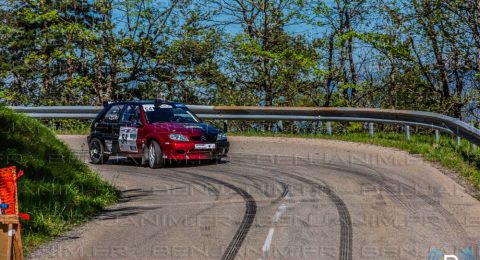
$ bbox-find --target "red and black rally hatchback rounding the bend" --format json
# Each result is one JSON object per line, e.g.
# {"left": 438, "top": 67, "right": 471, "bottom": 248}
{"left": 88, "top": 100, "right": 230, "bottom": 168}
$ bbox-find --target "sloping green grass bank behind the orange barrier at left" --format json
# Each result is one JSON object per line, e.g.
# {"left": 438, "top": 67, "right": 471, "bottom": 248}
{"left": 0, "top": 107, "right": 119, "bottom": 253}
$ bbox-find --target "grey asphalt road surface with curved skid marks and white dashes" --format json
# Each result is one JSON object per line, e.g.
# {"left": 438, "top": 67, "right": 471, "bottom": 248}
{"left": 30, "top": 136, "right": 480, "bottom": 260}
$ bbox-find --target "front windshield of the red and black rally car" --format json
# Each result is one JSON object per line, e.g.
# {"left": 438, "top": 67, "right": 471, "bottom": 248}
{"left": 143, "top": 104, "right": 200, "bottom": 124}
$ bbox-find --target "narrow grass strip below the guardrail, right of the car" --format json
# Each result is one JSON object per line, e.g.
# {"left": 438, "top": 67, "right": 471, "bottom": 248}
{"left": 229, "top": 131, "right": 480, "bottom": 191}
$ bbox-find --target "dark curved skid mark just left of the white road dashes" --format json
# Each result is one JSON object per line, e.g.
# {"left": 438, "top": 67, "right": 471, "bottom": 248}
{"left": 176, "top": 171, "right": 257, "bottom": 260}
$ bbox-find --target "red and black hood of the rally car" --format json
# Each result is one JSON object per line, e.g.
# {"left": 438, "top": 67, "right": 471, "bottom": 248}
{"left": 154, "top": 122, "right": 221, "bottom": 135}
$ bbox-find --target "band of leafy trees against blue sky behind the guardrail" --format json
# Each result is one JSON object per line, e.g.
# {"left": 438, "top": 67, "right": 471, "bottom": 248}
{"left": 0, "top": 0, "right": 480, "bottom": 118}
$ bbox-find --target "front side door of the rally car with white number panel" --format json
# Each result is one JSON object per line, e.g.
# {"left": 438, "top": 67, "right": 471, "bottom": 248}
{"left": 118, "top": 104, "right": 144, "bottom": 154}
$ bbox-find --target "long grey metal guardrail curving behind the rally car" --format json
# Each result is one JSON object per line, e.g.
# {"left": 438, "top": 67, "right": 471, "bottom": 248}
{"left": 10, "top": 105, "right": 480, "bottom": 145}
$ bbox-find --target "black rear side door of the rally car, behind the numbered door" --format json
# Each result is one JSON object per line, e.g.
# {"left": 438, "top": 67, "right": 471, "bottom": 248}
{"left": 97, "top": 105, "right": 124, "bottom": 154}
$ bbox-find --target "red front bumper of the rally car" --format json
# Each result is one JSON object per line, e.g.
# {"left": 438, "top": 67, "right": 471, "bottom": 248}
{"left": 162, "top": 141, "right": 230, "bottom": 160}
